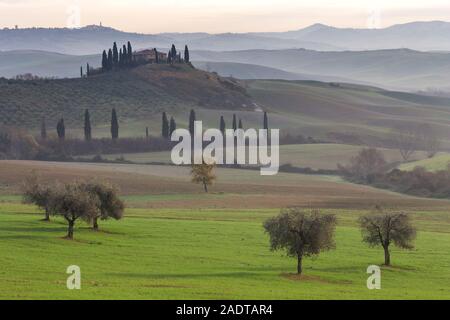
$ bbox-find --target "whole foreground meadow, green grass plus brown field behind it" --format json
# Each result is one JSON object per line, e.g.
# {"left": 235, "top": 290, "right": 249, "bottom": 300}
{"left": 0, "top": 161, "right": 450, "bottom": 299}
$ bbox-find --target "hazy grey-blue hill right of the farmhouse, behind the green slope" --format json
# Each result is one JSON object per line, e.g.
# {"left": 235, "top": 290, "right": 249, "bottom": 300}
{"left": 191, "top": 49, "right": 450, "bottom": 90}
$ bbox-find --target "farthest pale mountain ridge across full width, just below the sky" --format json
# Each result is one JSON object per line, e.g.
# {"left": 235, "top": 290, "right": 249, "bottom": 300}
{"left": 0, "top": 21, "right": 450, "bottom": 55}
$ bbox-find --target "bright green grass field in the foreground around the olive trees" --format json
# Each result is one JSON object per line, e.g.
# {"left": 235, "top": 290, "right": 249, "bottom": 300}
{"left": 0, "top": 202, "right": 450, "bottom": 299}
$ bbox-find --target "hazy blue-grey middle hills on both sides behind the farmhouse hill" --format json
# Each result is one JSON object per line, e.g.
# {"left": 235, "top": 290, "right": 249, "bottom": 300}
{"left": 4, "top": 49, "right": 450, "bottom": 91}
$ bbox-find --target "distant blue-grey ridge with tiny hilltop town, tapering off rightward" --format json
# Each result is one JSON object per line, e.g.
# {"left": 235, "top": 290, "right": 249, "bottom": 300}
{"left": 0, "top": 26, "right": 339, "bottom": 55}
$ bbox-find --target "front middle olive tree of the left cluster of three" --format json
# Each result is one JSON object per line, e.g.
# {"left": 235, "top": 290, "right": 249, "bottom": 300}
{"left": 50, "top": 183, "right": 100, "bottom": 240}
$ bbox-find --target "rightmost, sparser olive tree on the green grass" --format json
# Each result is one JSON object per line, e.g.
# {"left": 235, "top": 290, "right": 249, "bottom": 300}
{"left": 359, "top": 207, "right": 416, "bottom": 266}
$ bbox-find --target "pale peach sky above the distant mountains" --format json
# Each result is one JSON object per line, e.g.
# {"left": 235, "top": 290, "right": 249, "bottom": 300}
{"left": 0, "top": 0, "right": 450, "bottom": 33}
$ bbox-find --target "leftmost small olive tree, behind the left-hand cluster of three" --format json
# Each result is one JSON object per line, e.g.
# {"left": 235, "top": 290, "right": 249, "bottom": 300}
{"left": 22, "top": 172, "right": 58, "bottom": 221}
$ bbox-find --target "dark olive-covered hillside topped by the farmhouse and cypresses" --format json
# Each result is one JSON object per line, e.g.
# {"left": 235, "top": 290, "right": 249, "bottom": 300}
{"left": 0, "top": 64, "right": 252, "bottom": 128}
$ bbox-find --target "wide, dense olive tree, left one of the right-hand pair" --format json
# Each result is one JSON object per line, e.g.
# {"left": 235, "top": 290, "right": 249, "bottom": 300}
{"left": 264, "top": 208, "right": 336, "bottom": 274}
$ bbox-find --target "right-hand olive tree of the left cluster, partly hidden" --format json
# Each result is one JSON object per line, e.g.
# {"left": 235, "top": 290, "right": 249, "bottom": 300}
{"left": 82, "top": 181, "right": 125, "bottom": 231}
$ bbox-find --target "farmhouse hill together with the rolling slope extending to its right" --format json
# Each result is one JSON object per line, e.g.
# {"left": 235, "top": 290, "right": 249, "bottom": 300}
{"left": 0, "top": 65, "right": 450, "bottom": 147}
